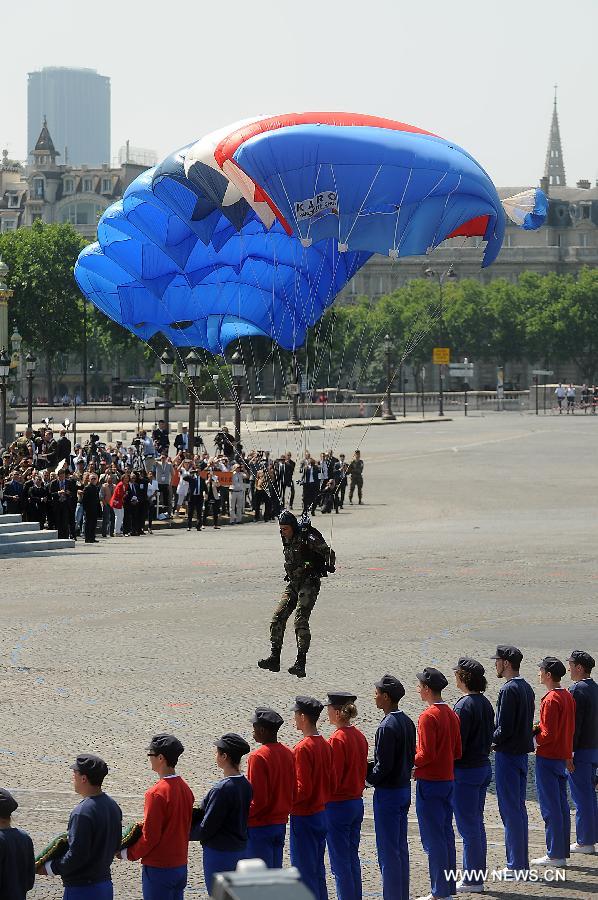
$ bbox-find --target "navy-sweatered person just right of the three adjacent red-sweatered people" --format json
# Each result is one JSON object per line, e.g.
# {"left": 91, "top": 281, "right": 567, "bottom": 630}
{"left": 367, "top": 675, "right": 415, "bottom": 900}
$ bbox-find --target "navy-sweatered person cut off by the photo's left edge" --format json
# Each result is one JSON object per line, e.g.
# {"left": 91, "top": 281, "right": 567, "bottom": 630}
{"left": 0, "top": 788, "right": 35, "bottom": 900}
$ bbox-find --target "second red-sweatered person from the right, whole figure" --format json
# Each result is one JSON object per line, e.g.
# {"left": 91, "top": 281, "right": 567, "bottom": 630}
{"left": 413, "top": 667, "right": 461, "bottom": 900}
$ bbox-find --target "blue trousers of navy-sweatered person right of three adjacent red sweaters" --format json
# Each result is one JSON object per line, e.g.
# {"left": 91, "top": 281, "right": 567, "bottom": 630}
{"left": 374, "top": 787, "right": 411, "bottom": 900}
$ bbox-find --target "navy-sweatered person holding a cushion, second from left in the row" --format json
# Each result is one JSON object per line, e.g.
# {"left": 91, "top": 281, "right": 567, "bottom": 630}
{"left": 36, "top": 753, "right": 122, "bottom": 900}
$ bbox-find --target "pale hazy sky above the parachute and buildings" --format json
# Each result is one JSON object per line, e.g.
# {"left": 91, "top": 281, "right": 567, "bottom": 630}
{"left": 0, "top": 0, "right": 598, "bottom": 186}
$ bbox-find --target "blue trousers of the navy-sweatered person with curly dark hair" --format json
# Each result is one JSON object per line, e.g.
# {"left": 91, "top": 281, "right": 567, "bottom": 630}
{"left": 453, "top": 763, "right": 492, "bottom": 884}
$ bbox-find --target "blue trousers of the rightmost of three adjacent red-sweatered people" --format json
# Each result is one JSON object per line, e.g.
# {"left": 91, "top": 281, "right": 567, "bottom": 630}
{"left": 326, "top": 797, "right": 363, "bottom": 900}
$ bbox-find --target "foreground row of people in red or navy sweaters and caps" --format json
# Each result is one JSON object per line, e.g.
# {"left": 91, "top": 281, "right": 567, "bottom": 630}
{"left": 0, "top": 645, "right": 598, "bottom": 900}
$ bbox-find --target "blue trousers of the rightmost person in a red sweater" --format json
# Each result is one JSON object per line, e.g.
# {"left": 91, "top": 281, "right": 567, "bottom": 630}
{"left": 536, "top": 755, "right": 571, "bottom": 859}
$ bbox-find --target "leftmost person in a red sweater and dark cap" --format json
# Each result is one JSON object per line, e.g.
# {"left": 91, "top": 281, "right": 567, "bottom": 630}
{"left": 120, "top": 734, "right": 194, "bottom": 900}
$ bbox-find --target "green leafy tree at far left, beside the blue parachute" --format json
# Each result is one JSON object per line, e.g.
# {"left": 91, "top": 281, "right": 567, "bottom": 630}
{"left": 0, "top": 221, "right": 86, "bottom": 402}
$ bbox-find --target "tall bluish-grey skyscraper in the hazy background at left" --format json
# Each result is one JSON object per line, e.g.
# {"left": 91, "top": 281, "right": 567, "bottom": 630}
{"left": 27, "top": 66, "right": 110, "bottom": 166}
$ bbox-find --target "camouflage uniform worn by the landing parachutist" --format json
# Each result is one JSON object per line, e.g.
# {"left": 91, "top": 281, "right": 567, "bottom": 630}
{"left": 270, "top": 534, "right": 328, "bottom": 653}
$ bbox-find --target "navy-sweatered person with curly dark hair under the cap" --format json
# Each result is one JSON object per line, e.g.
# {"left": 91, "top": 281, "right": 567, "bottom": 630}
{"left": 453, "top": 656, "right": 494, "bottom": 894}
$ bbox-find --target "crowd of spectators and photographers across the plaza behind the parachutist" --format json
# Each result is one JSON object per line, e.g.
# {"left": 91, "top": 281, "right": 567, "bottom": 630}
{"left": 0, "top": 421, "right": 363, "bottom": 543}
